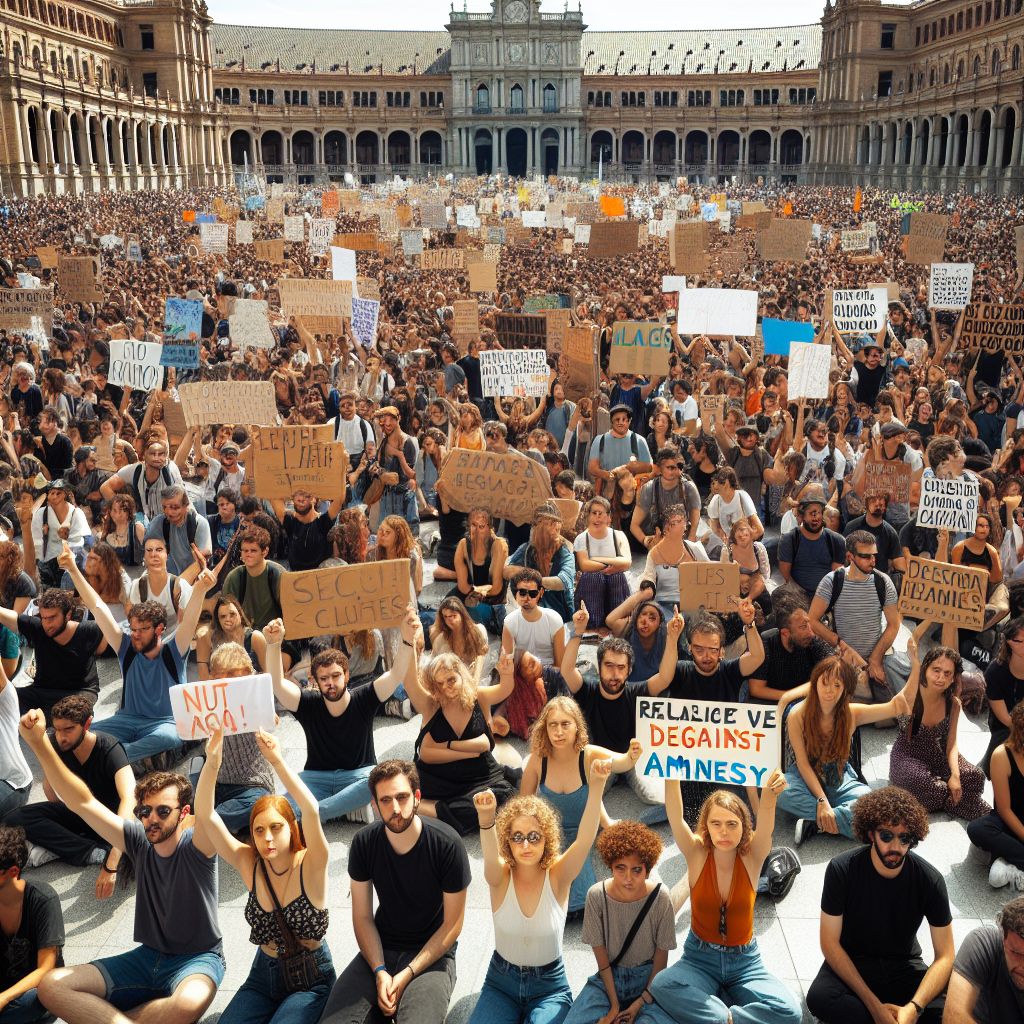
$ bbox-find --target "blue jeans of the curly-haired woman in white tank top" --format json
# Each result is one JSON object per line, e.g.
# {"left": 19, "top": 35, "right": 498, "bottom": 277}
{"left": 469, "top": 952, "right": 572, "bottom": 1024}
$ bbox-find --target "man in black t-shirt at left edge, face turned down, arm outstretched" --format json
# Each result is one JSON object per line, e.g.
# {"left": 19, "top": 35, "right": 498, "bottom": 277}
{"left": 0, "top": 588, "right": 103, "bottom": 718}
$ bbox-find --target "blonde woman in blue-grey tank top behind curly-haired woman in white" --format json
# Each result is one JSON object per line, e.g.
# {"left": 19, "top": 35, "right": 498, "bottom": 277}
{"left": 519, "top": 696, "right": 641, "bottom": 916}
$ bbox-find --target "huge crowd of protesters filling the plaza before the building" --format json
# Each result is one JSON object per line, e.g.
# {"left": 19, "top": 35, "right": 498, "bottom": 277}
{"left": 0, "top": 178, "right": 1024, "bottom": 1024}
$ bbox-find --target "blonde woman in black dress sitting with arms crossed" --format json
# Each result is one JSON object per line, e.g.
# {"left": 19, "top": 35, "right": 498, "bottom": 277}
{"left": 406, "top": 653, "right": 520, "bottom": 836}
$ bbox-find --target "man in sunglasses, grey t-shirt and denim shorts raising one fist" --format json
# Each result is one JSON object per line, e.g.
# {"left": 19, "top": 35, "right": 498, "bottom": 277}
{"left": 19, "top": 708, "right": 225, "bottom": 1024}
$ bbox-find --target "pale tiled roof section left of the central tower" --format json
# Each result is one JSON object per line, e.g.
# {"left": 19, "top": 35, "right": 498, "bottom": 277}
{"left": 210, "top": 24, "right": 452, "bottom": 75}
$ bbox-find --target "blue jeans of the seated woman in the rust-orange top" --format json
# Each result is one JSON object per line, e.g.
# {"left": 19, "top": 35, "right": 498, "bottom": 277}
{"left": 650, "top": 932, "right": 803, "bottom": 1024}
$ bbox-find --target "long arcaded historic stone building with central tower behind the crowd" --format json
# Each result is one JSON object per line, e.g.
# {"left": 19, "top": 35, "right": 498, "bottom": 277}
{"left": 0, "top": 0, "right": 1024, "bottom": 195}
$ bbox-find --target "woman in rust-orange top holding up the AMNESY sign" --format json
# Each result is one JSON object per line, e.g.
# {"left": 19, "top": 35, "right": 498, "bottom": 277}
{"left": 641, "top": 774, "right": 803, "bottom": 1024}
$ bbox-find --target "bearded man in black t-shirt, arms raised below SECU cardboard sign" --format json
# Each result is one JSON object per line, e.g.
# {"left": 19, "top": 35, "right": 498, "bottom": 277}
{"left": 272, "top": 608, "right": 419, "bottom": 824}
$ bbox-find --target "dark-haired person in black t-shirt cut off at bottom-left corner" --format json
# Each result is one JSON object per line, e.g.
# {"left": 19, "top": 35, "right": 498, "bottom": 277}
{"left": 0, "top": 825, "right": 65, "bottom": 1024}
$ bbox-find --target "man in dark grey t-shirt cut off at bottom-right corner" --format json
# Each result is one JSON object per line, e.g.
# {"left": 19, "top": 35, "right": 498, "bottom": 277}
{"left": 946, "top": 896, "right": 1024, "bottom": 1024}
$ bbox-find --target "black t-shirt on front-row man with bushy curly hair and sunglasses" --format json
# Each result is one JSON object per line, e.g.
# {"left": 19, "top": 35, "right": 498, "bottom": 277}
{"left": 821, "top": 846, "right": 952, "bottom": 961}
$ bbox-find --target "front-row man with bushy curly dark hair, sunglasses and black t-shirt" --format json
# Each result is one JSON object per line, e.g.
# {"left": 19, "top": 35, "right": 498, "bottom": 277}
{"left": 807, "top": 785, "right": 955, "bottom": 1024}
